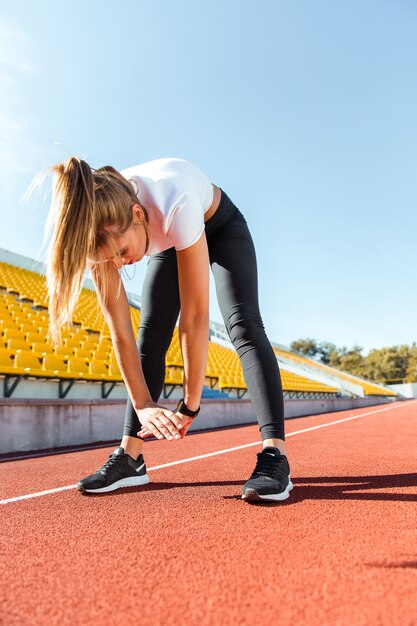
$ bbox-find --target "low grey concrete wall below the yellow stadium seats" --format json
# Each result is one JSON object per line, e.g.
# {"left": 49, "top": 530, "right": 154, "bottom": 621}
{"left": 0, "top": 398, "right": 400, "bottom": 454}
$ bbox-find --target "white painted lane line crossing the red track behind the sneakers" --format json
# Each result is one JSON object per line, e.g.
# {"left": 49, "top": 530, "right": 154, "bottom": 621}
{"left": 0, "top": 403, "right": 402, "bottom": 504}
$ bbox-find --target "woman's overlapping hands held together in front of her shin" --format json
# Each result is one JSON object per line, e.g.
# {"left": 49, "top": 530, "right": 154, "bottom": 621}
{"left": 137, "top": 404, "right": 193, "bottom": 440}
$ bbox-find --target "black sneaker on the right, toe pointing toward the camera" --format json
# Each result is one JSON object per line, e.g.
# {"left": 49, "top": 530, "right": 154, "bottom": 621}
{"left": 242, "top": 447, "right": 294, "bottom": 501}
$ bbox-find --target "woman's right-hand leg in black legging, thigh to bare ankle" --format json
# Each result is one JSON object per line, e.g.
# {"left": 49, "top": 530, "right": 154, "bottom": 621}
{"left": 208, "top": 212, "right": 285, "bottom": 454}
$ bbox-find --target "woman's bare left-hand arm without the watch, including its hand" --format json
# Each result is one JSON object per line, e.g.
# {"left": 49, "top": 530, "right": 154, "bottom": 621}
{"left": 91, "top": 263, "right": 181, "bottom": 438}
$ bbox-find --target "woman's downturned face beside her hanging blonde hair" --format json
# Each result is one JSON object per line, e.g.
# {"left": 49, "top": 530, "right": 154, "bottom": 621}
{"left": 102, "top": 205, "right": 148, "bottom": 269}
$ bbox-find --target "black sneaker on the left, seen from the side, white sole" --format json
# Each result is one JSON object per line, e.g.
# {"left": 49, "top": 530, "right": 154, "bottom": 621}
{"left": 77, "top": 447, "right": 149, "bottom": 493}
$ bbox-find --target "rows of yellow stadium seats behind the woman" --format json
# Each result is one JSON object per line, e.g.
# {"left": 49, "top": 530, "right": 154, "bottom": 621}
{"left": 0, "top": 263, "right": 395, "bottom": 397}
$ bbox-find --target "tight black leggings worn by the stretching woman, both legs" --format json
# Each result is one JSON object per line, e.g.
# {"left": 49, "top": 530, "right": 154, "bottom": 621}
{"left": 123, "top": 190, "right": 285, "bottom": 439}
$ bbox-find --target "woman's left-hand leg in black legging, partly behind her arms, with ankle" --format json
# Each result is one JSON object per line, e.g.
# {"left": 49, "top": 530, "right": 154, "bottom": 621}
{"left": 121, "top": 248, "right": 180, "bottom": 457}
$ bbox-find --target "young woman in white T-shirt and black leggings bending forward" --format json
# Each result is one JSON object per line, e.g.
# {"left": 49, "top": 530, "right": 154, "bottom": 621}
{"left": 47, "top": 157, "right": 292, "bottom": 500}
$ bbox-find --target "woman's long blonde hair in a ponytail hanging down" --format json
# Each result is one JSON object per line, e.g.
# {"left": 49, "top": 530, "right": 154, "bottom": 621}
{"left": 46, "top": 157, "right": 147, "bottom": 343}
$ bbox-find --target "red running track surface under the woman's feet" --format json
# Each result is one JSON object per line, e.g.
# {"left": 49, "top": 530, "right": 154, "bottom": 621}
{"left": 0, "top": 401, "right": 417, "bottom": 626}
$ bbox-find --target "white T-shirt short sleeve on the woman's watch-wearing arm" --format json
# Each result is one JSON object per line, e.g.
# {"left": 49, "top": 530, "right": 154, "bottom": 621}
{"left": 164, "top": 191, "right": 204, "bottom": 250}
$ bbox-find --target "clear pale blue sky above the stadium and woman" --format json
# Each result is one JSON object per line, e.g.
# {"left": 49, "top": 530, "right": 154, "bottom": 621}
{"left": 0, "top": 0, "right": 417, "bottom": 354}
